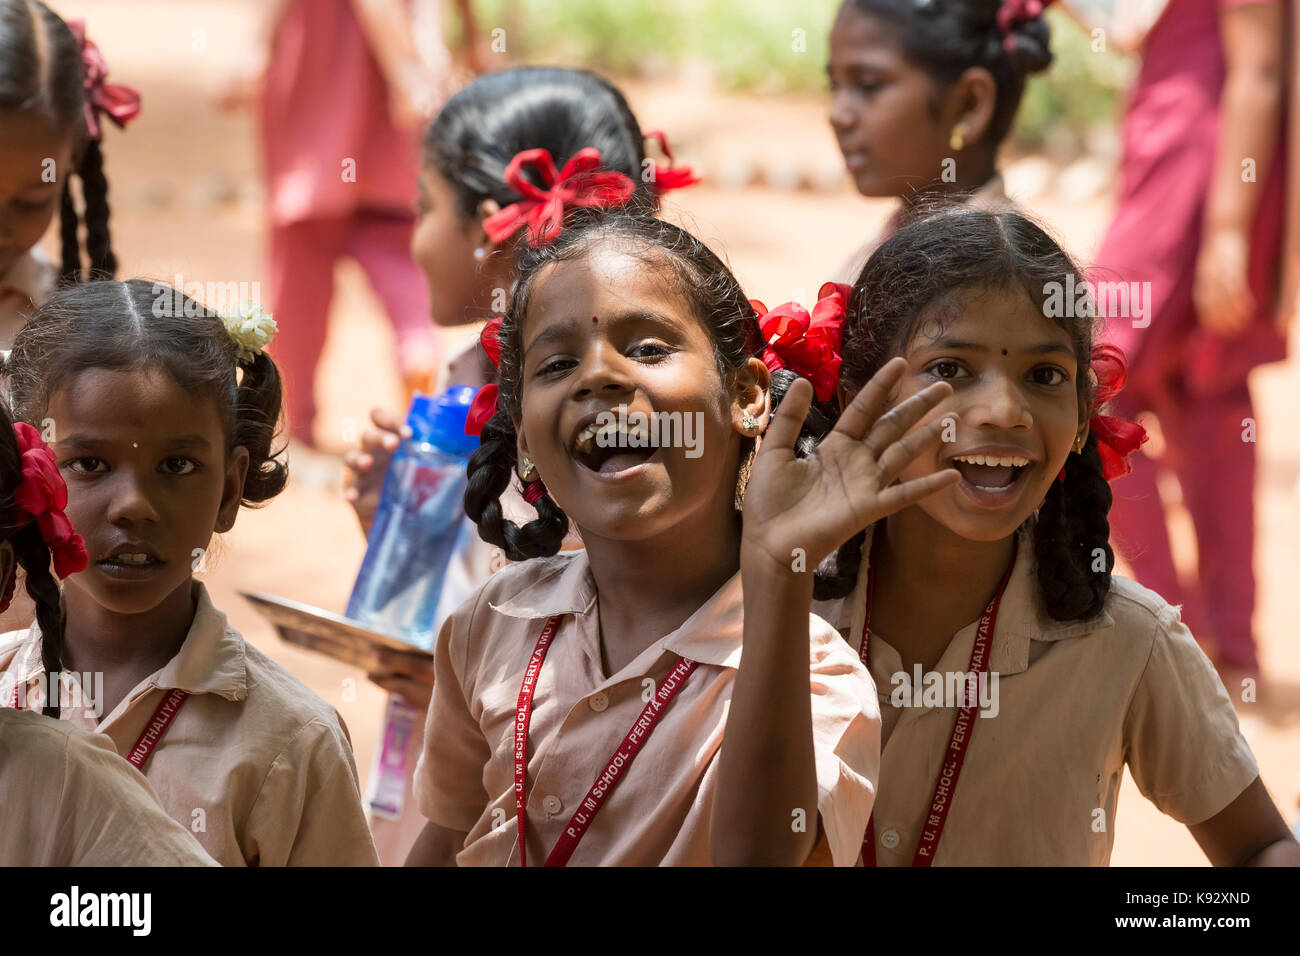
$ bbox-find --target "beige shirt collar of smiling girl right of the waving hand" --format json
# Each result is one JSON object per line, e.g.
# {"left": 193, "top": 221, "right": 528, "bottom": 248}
{"left": 841, "top": 519, "right": 1115, "bottom": 675}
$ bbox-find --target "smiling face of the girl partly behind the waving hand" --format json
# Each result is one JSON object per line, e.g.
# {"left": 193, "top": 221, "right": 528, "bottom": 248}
{"left": 863, "top": 283, "right": 1087, "bottom": 541}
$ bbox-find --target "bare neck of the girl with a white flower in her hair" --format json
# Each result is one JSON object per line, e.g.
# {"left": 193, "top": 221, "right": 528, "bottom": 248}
{"left": 62, "top": 579, "right": 195, "bottom": 687}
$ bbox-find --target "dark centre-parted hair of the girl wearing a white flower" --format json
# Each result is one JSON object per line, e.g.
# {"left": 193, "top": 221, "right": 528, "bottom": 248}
{"left": 5, "top": 278, "right": 289, "bottom": 506}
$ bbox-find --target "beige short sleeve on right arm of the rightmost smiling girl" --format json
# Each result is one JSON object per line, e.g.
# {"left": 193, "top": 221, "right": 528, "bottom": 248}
{"left": 1125, "top": 607, "right": 1260, "bottom": 826}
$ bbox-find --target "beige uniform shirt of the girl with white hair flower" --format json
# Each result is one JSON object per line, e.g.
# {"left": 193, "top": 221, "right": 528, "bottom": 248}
{"left": 0, "top": 581, "right": 378, "bottom": 866}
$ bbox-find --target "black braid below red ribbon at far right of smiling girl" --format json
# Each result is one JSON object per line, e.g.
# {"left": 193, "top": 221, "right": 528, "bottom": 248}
{"left": 1034, "top": 433, "right": 1115, "bottom": 620}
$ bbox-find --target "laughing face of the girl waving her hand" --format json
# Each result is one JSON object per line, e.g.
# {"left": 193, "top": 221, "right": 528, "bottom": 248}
{"left": 517, "top": 242, "right": 768, "bottom": 541}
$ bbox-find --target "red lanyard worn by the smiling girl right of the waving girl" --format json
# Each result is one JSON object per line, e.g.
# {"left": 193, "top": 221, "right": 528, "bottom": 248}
{"left": 861, "top": 551, "right": 1015, "bottom": 866}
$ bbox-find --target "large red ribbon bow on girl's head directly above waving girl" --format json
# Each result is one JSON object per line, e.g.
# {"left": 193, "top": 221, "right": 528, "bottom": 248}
{"left": 484, "top": 146, "right": 637, "bottom": 246}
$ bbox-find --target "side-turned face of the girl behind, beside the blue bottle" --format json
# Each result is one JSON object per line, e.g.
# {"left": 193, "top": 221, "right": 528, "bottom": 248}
{"left": 411, "top": 164, "right": 512, "bottom": 325}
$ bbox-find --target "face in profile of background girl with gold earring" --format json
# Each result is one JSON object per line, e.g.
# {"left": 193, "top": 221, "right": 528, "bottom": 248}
{"left": 826, "top": 4, "right": 957, "bottom": 196}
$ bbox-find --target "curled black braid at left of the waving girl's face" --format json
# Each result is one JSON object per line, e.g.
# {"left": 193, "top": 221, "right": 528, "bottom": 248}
{"left": 465, "top": 408, "right": 568, "bottom": 561}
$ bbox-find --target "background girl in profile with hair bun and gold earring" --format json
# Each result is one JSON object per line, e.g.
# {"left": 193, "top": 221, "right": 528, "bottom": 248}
{"left": 827, "top": 0, "right": 1052, "bottom": 282}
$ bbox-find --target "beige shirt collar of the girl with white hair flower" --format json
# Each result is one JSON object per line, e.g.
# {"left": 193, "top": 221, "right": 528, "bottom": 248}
{"left": 18, "top": 581, "right": 248, "bottom": 701}
